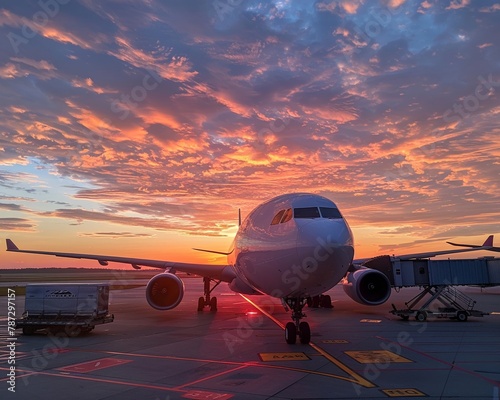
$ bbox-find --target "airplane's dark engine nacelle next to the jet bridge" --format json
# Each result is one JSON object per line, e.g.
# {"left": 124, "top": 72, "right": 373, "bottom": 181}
{"left": 342, "top": 268, "right": 391, "bottom": 306}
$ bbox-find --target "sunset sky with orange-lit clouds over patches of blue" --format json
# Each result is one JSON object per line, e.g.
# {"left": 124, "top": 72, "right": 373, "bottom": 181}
{"left": 0, "top": 0, "right": 500, "bottom": 268}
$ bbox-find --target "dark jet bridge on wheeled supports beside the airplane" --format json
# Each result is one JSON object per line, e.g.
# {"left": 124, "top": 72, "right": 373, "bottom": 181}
{"left": 364, "top": 256, "right": 500, "bottom": 321}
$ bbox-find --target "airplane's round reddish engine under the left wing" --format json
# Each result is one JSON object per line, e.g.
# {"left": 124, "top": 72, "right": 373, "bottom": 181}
{"left": 146, "top": 272, "right": 184, "bottom": 310}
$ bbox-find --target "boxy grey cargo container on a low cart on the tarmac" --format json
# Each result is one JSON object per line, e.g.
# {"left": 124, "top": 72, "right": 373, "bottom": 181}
{"left": 16, "top": 283, "right": 114, "bottom": 336}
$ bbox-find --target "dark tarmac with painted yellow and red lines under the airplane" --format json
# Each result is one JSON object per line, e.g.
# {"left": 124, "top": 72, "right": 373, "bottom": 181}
{"left": 0, "top": 278, "right": 500, "bottom": 400}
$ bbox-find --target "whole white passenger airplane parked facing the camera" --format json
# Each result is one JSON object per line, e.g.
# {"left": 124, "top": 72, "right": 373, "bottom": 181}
{"left": 7, "top": 193, "right": 500, "bottom": 344}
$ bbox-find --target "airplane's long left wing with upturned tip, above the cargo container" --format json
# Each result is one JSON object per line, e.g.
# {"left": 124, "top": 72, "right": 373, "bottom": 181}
{"left": 7, "top": 239, "right": 236, "bottom": 282}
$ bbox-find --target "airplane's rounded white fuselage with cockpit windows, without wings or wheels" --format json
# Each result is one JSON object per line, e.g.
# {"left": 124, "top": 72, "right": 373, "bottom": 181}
{"left": 228, "top": 194, "right": 354, "bottom": 298}
